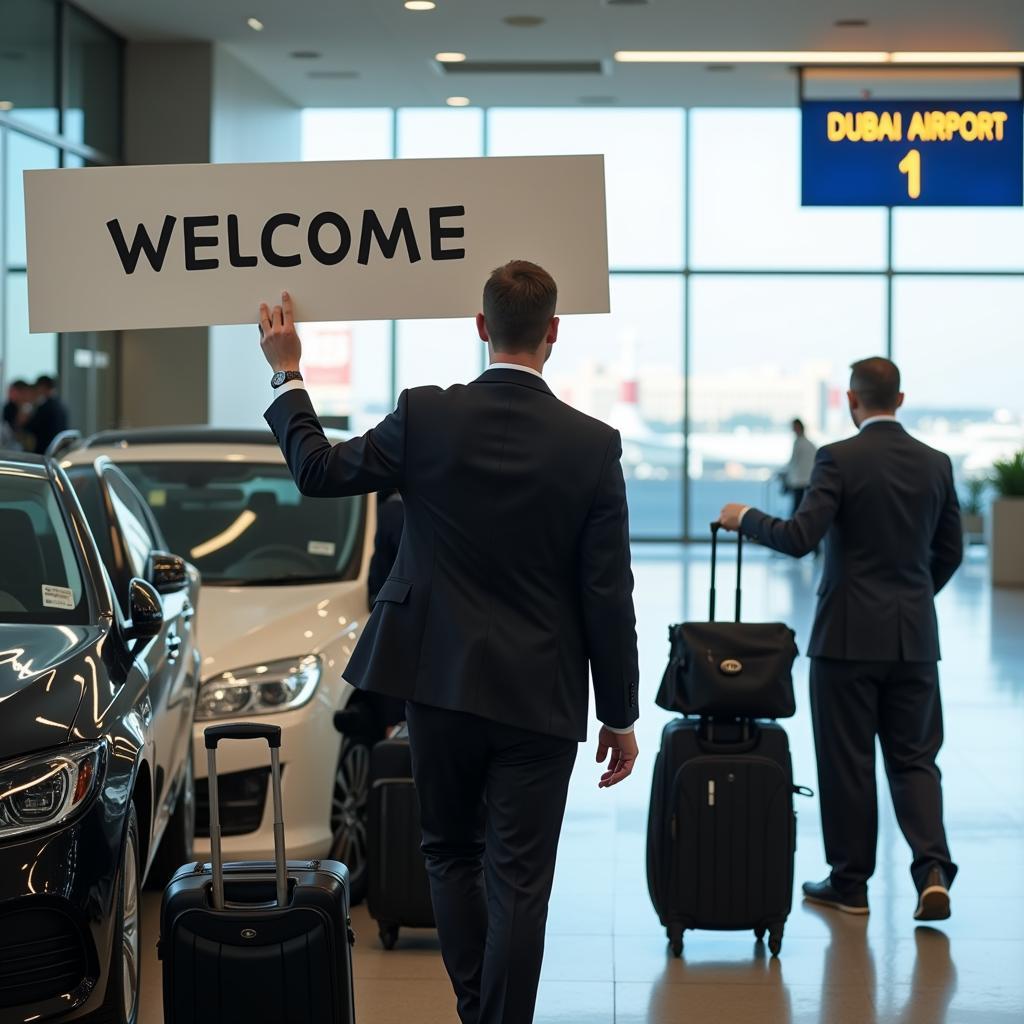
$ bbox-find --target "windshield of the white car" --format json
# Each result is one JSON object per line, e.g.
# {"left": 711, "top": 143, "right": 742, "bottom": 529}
{"left": 118, "top": 461, "right": 365, "bottom": 586}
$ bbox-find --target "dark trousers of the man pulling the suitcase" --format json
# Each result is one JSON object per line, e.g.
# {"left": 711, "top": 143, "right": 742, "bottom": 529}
{"left": 811, "top": 657, "right": 956, "bottom": 894}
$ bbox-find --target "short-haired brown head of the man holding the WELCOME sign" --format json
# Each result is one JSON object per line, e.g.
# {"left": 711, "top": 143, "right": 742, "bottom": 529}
{"left": 483, "top": 259, "right": 558, "bottom": 352}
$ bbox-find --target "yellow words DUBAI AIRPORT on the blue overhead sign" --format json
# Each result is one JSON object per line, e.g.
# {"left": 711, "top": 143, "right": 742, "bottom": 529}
{"left": 827, "top": 111, "right": 1009, "bottom": 142}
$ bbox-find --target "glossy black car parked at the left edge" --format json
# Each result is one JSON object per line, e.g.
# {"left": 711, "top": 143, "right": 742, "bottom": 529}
{"left": 0, "top": 455, "right": 200, "bottom": 1024}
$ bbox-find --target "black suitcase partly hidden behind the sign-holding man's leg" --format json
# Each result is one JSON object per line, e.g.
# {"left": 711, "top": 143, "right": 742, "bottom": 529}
{"left": 367, "top": 728, "right": 434, "bottom": 949}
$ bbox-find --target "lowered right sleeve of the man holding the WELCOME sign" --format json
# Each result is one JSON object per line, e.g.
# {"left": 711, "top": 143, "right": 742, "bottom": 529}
{"left": 580, "top": 432, "right": 640, "bottom": 729}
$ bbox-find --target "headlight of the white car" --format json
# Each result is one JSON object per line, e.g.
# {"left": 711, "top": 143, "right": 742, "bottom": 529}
{"left": 196, "top": 654, "right": 321, "bottom": 722}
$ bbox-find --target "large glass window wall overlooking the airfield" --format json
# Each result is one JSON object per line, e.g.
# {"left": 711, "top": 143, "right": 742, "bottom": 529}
{"left": 296, "top": 108, "right": 1024, "bottom": 539}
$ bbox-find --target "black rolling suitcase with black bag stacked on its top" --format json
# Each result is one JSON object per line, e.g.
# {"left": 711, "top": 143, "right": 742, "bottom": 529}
{"left": 647, "top": 523, "right": 810, "bottom": 956}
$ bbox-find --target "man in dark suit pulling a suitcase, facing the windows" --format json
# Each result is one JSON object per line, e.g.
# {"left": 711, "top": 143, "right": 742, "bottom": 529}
{"left": 721, "top": 358, "right": 964, "bottom": 921}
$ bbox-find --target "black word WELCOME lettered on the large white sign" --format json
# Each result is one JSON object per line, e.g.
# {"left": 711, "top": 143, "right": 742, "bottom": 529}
{"left": 106, "top": 206, "right": 466, "bottom": 274}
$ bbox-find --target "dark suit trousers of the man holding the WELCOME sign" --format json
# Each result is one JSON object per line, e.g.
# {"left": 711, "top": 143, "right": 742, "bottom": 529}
{"left": 407, "top": 702, "right": 579, "bottom": 1024}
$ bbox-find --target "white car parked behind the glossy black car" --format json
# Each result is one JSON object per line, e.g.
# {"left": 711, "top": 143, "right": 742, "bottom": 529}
{"left": 62, "top": 427, "right": 382, "bottom": 896}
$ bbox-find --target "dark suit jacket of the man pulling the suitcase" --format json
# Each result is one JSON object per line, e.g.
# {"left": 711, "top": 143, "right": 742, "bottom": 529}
{"left": 742, "top": 421, "right": 964, "bottom": 662}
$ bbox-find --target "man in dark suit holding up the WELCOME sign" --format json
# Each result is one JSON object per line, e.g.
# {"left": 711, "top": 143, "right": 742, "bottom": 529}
{"left": 260, "top": 261, "right": 638, "bottom": 1024}
